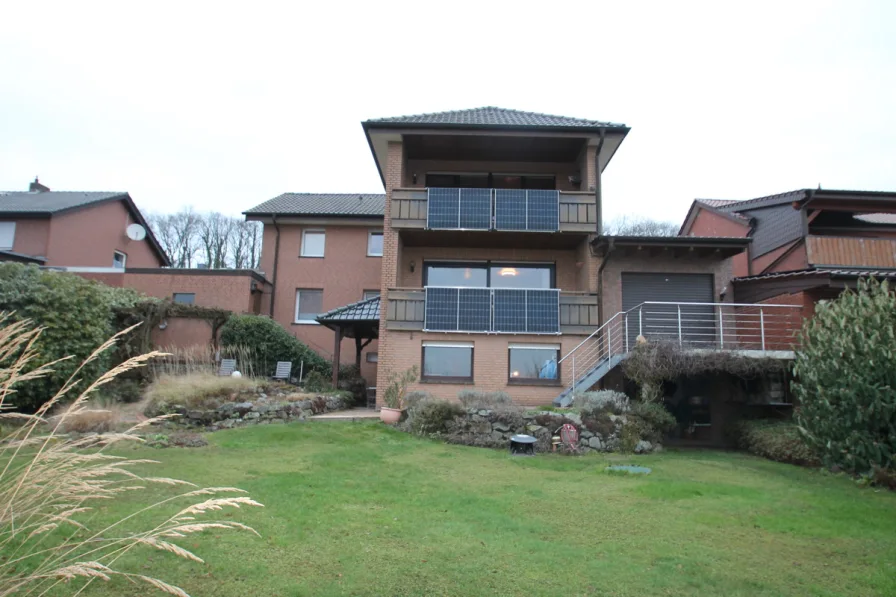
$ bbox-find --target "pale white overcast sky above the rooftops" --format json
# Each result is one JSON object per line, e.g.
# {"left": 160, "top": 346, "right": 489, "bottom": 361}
{"left": 0, "top": 0, "right": 896, "bottom": 221}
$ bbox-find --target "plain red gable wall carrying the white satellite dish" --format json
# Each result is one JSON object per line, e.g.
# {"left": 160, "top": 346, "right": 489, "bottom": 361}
{"left": 43, "top": 201, "right": 162, "bottom": 267}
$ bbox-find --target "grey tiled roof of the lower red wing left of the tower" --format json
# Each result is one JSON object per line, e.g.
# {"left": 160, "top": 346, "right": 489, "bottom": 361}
{"left": 243, "top": 193, "right": 386, "bottom": 217}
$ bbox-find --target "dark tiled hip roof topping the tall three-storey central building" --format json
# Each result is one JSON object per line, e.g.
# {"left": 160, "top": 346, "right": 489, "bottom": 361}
{"left": 367, "top": 106, "right": 625, "bottom": 129}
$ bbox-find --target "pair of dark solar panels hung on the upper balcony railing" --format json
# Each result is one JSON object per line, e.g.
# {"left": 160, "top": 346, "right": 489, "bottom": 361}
{"left": 426, "top": 188, "right": 560, "bottom": 232}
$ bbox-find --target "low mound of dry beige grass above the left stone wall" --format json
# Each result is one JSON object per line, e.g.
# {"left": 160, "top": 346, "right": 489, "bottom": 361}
{"left": 145, "top": 373, "right": 268, "bottom": 415}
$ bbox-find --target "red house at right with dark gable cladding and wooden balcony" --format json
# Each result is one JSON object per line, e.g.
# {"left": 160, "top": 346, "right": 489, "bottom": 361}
{"left": 679, "top": 189, "right": 896, "bottom": 317}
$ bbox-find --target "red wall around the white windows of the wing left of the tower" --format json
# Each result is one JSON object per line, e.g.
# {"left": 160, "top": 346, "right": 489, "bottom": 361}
{"left": 261, "top": 223, "right": 383, "bottom": 385}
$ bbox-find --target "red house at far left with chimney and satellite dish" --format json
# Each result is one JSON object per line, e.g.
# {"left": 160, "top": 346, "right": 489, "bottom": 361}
{"left": 0, "top": 179, "right": 170, "bottom": 271}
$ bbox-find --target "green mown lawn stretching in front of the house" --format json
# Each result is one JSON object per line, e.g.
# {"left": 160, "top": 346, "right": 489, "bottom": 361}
{"left": 80, "top": 423, "right": 896, "bottom": 597}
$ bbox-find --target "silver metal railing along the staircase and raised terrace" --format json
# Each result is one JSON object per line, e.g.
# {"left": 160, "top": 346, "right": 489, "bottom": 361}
{"left": 559, "top": 302, "right": 802, "bottom": 392}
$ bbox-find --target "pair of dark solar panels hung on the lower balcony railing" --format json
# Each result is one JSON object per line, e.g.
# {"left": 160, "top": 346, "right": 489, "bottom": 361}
{"left": 423, "top": 286, "right": 560, "bottom": 334}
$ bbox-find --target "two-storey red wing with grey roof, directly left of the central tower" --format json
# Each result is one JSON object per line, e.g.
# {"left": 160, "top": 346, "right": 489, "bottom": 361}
{"left": 245, "top": 193, "right": 385, "bottom": 378}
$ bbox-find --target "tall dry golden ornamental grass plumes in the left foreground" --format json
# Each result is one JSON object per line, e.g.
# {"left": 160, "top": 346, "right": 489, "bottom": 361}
{"left": 0, "top": 313, "right": 261, "bottom": 597}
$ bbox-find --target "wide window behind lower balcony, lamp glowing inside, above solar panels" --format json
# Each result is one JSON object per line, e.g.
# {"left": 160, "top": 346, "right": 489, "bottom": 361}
{"left": 423, "top": 263, "right": 554, "bottom": 289}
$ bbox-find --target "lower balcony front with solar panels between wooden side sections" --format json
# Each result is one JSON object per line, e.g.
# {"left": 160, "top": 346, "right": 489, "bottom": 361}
{"left": 386, "top": 286, "right": 597, "bottom": 335}
